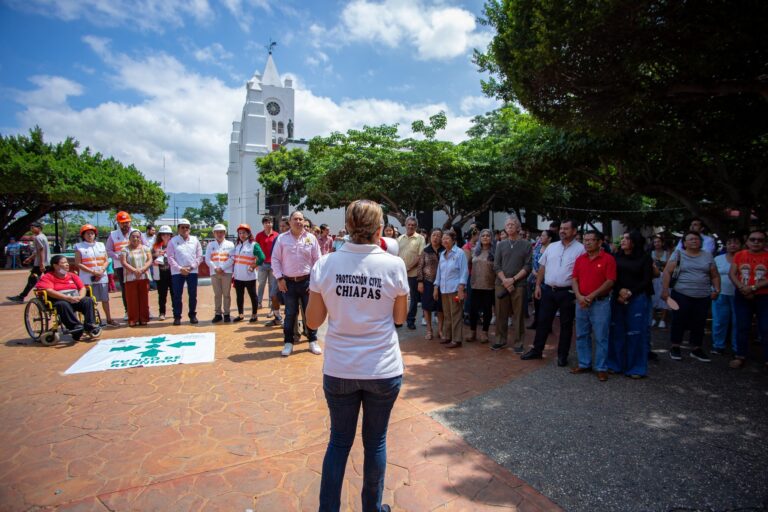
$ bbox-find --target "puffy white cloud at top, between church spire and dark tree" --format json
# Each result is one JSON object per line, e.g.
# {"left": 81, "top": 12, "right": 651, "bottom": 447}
{"left": 318, "top": 0, "right": 492, "bottom": 60}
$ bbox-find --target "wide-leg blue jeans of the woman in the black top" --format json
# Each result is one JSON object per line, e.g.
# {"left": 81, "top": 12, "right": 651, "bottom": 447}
{"left": 608, "top": 293, "right": 648, "bottom": 375}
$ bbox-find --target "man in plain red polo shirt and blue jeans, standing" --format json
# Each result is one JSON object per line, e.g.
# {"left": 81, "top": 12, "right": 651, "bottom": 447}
{"left": 571, "top": 231, "right": 616, "bottom": 382}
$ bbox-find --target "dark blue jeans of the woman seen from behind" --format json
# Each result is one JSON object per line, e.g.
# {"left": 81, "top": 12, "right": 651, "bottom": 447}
{"left": 320, "top": 375, "right": 403, "bottom": 512}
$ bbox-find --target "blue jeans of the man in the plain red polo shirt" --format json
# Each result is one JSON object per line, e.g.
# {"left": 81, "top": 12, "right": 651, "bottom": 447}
{"left": 576, "top": 299, "right": 611, "bottom": 372}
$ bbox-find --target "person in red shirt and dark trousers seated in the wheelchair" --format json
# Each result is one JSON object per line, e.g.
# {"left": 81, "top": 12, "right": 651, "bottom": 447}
{"left": 35, "top": 255, "right": 101, "bottom": 341}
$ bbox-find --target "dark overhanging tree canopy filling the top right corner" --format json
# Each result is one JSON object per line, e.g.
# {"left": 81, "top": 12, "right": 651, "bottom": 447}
{"left": 475, "top": 0, "right": 768, "bottom": 235}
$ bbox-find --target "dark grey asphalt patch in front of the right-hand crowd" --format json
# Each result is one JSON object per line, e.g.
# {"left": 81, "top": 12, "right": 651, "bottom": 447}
{"left": 434, "top": 332, "right": 768, "bottom": 512}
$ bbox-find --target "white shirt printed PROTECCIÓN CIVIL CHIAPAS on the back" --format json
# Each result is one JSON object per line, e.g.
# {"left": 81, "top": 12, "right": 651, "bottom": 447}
{"left": 309, "top": 242, "right": 409, "bottom": 380}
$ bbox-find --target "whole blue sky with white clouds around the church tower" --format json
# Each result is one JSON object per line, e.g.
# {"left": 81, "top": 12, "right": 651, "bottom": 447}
{"left": 0, "top": 0, "right": 496, "bottom": 193}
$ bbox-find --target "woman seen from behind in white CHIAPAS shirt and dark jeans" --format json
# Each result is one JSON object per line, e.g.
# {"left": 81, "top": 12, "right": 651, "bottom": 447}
{"left": 307, "top": 200, "right": 409, "bottom": 512}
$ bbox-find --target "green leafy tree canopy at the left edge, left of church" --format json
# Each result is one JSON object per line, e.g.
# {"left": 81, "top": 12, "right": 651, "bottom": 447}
{"left": 0, "top": 127, "right": 166, "bottom": 246}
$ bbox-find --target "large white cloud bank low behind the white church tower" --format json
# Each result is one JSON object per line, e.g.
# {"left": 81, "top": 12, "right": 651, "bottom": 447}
{"left": 10, "top": 43, "right": 480, "bottom": 192}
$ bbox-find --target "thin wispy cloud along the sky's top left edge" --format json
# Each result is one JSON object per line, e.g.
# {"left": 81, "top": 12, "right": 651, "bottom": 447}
{"left": 6, "top": 0, "right": 213, "bottom": 32}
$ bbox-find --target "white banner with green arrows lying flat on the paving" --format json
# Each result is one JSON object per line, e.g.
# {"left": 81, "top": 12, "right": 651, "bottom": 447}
{"left": 64, "top": 332, "right": 216, "bottom": 375}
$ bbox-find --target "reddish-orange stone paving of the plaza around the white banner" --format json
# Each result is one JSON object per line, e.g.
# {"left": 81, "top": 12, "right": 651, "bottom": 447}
{"left": 0, "top": 271, "right": 558, "bottom": 511}
